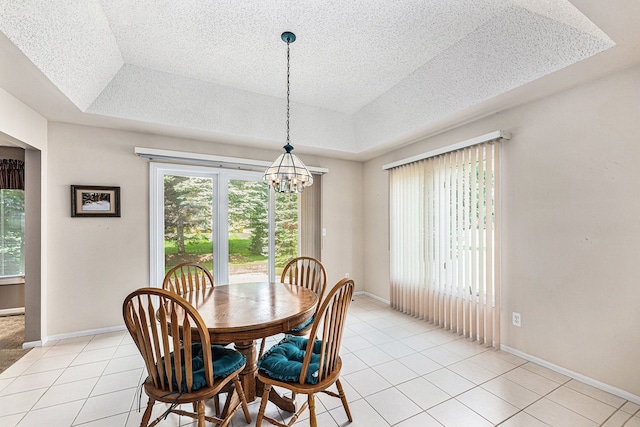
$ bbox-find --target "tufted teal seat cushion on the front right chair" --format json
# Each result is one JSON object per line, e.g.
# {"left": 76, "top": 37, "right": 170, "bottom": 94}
{"left": 258, "top": 335, "right": 322, "bottom": 384}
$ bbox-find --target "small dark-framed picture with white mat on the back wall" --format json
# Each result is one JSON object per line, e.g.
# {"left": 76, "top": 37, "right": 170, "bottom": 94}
{"left": 71, "top": 185, "right": 120, "bottom": 217}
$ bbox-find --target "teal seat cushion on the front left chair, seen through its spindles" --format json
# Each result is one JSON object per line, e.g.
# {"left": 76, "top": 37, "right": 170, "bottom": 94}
{"left": 162, "top": 342, "right": 246, "bottom": 393}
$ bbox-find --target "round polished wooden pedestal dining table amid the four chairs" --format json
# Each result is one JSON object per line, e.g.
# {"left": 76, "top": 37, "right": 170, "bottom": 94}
{"left": 183, "top": 282, "right": 318, "bottom": 411}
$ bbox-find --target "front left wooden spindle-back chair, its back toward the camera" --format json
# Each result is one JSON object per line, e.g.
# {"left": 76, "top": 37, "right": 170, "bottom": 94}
{"left": 122, "top": 288, "right": 251, "bottom": 427}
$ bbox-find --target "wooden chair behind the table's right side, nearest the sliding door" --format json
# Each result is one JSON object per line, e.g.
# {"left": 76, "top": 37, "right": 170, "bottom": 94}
{"left": 258, "top": 256, "right": 327, "bottom": 357}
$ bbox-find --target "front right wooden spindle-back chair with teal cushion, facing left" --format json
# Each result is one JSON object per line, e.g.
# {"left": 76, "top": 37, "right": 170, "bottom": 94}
{"left": 256, "top": 279, "right": 355, "bottom": 427}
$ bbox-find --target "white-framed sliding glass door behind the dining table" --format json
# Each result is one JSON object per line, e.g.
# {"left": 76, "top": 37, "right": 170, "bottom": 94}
{"left": 151, "top": 163, "right": 299, "bottom": 286}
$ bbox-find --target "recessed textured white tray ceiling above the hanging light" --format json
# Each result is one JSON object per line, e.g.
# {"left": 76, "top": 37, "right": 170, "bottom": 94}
{"left": 0, "top": 0, "right": 632, "bottom": 157}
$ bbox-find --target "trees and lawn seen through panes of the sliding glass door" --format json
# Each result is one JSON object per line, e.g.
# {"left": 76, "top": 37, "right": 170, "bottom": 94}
{"left": 164, "top": 175, "right": 298, "bottom": 283}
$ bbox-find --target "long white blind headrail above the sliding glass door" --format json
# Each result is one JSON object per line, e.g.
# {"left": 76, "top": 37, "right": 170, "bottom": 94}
{"left": 134, "top": 147, "right": 329, "bottom": 174}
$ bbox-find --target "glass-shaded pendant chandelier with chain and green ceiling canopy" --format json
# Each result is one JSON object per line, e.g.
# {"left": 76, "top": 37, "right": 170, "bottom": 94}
{"left": 262, "top": 31, "right": 313, "bottom": 193}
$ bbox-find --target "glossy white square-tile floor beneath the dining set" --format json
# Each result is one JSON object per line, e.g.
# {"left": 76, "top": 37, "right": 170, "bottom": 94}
{"left": 0, "top": 295, "right": 640, "bottom": 427}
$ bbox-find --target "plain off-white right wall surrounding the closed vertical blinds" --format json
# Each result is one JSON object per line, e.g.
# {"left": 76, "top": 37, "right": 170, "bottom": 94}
{"left": 364, "top": 66, "right": 640, "bottom": 396}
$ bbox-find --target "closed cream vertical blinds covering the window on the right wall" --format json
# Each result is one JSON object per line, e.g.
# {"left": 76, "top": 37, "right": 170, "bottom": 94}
{"left": 389, "top": 141, "right": 500, "bottom": 348}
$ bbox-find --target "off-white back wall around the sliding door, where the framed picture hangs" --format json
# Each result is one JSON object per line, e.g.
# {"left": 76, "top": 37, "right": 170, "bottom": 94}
{"left": 46, "top": 123, "right": 363, "bottom": 337}
